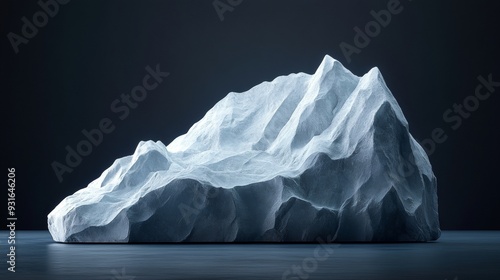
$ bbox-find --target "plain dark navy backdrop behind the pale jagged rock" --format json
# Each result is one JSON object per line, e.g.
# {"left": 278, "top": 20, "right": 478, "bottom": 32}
{"left": 0, "top": 0, "right": 500, "bottom": 230}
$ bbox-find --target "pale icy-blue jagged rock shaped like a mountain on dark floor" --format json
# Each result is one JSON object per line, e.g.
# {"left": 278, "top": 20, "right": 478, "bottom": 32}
{"left": 48, "top": 56, "right": 440, "bottom": 242}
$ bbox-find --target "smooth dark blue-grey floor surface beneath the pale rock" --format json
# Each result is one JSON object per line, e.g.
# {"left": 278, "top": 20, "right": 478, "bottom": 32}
{"left": 0, "top": 231, "right": 500, "bottom": 280}
